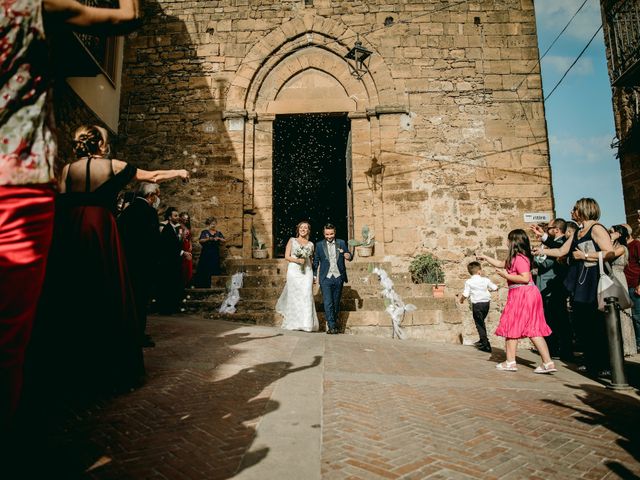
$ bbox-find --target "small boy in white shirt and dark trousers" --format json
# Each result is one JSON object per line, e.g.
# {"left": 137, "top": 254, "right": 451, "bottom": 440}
{"left": 460, "top": 262, "right": 498, "bottom": 352}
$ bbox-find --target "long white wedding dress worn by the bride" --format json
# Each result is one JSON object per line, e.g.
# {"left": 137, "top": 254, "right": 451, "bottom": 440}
{"left": 276, "top": 238, "right": 320, "bottom": 332}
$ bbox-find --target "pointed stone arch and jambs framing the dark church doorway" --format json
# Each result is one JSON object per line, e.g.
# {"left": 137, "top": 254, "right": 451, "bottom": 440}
{"left": 224, "top": 16, "right": 408, "bottom": 257}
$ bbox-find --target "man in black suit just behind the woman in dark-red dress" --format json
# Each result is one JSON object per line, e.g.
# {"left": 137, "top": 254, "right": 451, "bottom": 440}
{"left": 118, "top": 182, "right": 160, "bottom": 347}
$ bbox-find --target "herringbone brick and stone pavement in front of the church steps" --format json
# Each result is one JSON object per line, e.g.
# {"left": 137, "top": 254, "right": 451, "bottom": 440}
{"left": 2, "top": 317, "right": 640, "bottom": 480}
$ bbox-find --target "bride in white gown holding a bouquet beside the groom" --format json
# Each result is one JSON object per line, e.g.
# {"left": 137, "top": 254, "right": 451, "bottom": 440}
{"left": 276, "top": 222, "right": 319, "bottom": 332}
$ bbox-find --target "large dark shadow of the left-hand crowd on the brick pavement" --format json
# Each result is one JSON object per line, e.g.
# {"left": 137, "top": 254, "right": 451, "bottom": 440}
{"left": 3, "top": 320, "right": 321, "bottom": 479}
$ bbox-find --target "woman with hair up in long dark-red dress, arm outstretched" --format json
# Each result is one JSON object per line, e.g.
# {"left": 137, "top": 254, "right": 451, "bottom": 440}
{"left": 32, "top": 126, "right": 188, "bottom": 392}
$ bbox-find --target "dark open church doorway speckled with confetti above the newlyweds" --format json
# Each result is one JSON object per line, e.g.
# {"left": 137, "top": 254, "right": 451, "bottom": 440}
{"left": 273, "top": 114, "right": 350, "bottom": 257}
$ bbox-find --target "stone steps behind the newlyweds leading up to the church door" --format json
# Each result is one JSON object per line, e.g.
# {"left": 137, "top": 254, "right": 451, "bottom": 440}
{"left": 185, "top": 259, "right": 462, "bottom": 343}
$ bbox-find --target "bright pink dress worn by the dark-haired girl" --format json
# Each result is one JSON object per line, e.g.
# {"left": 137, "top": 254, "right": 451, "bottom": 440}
{"left": 496, "top": 254, "right": 551, "bottom": 338}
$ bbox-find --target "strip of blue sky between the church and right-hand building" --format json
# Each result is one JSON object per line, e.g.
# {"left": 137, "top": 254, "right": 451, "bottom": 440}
{"left": 534, "top": 0, "right": 626, "bottom": 226}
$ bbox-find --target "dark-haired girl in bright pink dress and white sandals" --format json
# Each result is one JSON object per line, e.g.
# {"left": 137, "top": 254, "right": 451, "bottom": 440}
{"left": 478, "top": 229, "right": 557, "bottom": 373}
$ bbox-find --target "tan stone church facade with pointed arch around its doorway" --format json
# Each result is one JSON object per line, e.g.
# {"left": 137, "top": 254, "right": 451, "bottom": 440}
{"left": 117, "top": 0, "right": 553, "bottom": 292}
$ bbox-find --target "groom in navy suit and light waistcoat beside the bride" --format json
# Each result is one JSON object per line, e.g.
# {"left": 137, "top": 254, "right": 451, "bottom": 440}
{"left": 313, "top": 223, "right": 351, "bottom": 334}
